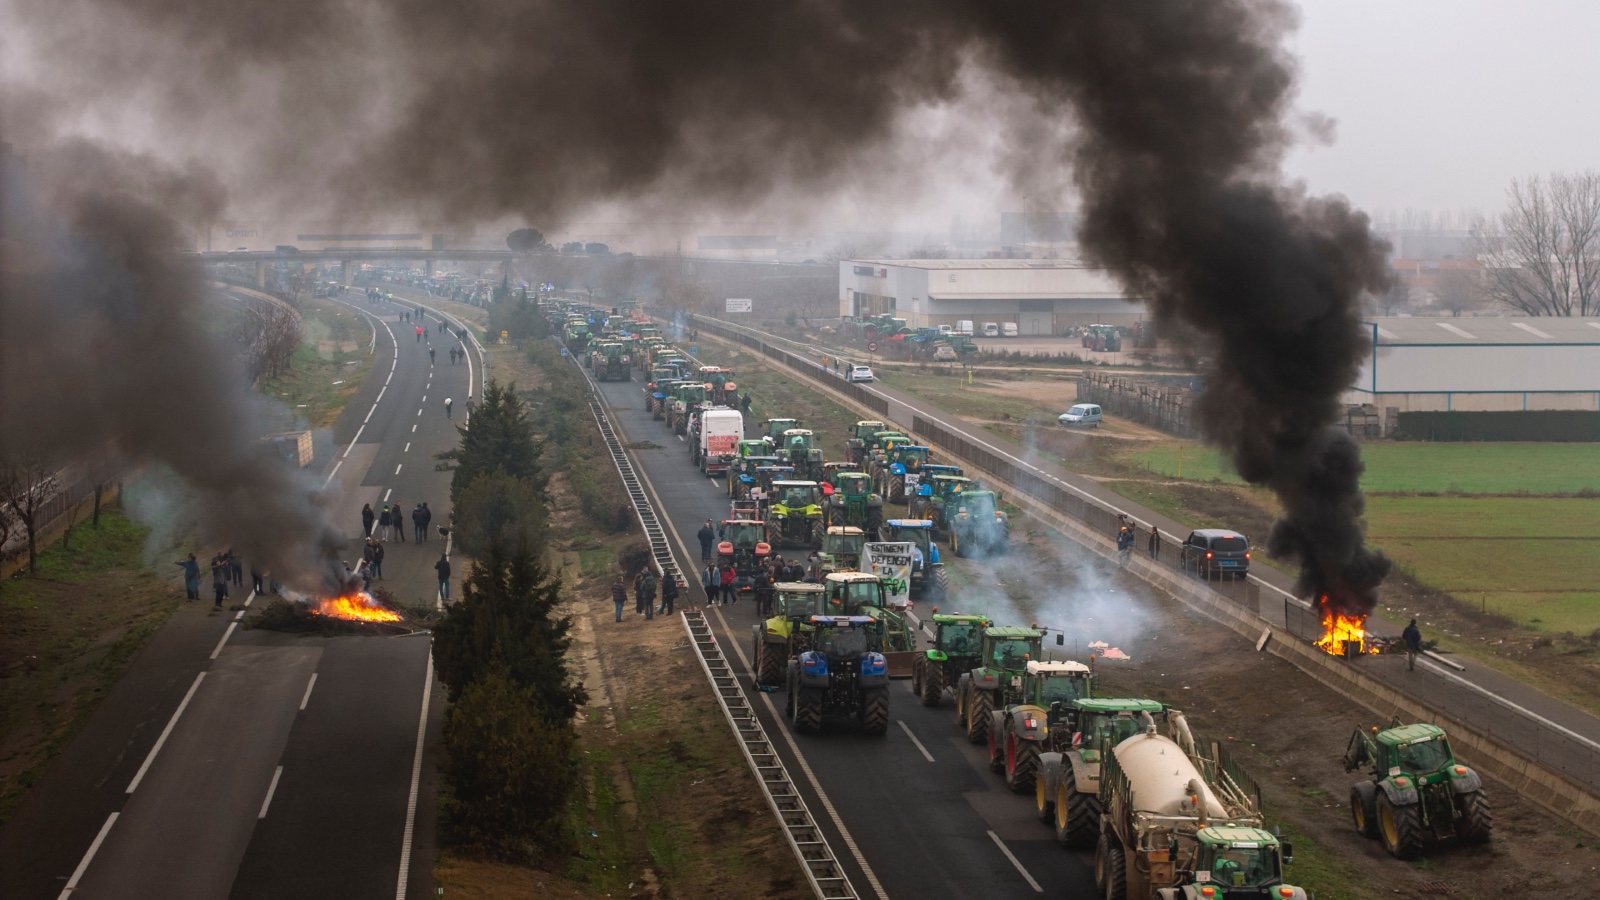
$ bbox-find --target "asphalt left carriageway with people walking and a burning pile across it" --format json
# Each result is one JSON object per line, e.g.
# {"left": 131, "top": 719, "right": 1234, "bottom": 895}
{"left": 0, "top": 293, "right": 482, "bottom": 900}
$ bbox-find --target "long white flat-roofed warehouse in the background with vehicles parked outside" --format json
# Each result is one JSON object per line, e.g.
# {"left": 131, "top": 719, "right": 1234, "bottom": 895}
{"left": 838, "top": 259, "right": 1146, "bottom": 335}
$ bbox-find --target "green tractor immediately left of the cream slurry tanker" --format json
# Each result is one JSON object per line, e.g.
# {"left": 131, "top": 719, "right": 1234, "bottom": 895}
{"left": 1034, "top": 697, "right": 1166, "bottom": 849}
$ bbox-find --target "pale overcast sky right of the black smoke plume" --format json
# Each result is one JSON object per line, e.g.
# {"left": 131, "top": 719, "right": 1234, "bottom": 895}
{"left": 1288, "top": 0, "right": 1600, "bottom": 213}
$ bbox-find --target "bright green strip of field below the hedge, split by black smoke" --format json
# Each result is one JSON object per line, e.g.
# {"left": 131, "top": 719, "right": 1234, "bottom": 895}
{"left": 1126, "top": 440, "right": 1600, "bottom": 495}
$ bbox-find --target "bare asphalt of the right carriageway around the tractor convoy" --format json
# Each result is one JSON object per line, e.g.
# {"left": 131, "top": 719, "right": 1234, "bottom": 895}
{"left": 582, "top": 353, "right": 1094, "bottom": 898}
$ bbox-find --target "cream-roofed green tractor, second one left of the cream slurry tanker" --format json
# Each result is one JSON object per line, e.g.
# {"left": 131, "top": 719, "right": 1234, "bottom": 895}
{"left": 989, "top": 660, "right": 1094, "bottom": 794}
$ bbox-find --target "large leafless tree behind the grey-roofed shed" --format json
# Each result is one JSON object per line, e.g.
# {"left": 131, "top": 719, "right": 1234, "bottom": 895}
{"left": 1470, "top": 170, "right": 1600, "bottom": 315}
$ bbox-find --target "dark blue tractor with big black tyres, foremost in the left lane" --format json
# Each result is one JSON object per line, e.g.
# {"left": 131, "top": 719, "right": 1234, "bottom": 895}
{"left": 784, "top": 615, "right": 890, "bottom": 735}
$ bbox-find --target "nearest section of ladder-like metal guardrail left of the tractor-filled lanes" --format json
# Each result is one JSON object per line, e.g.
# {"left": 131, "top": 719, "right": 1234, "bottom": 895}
{"left": 682, "top": 609, "right": 856, "bottom": 900}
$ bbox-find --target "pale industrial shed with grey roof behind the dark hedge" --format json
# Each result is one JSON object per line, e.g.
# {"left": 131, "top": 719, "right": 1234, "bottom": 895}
{"left": 1344, "top": 317, "right": 1600, "bottom": 413}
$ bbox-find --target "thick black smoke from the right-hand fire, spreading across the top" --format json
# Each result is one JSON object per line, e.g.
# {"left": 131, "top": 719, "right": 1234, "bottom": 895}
{"left": 11, "top": 0, "right": 1389, "bottom": 612}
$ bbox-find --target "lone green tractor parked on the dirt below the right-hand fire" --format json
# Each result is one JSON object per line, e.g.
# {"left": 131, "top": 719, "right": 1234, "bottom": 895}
{"left": 1344, "top": 717, "right": 1494, "bottom": 860}
